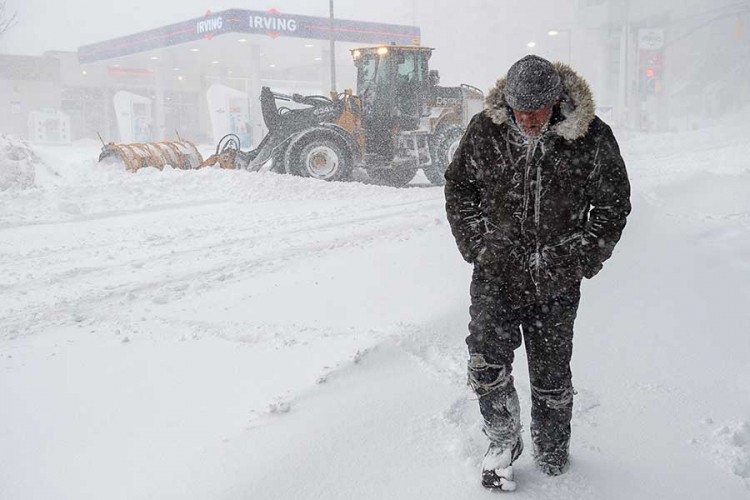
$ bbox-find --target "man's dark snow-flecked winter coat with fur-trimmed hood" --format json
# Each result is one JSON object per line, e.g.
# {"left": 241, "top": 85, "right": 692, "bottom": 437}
{"left": 445, "top": 63, "right": 630, "bottom": 307}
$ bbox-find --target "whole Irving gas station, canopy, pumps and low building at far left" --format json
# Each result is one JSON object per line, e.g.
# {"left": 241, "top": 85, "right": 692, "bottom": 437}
{"left": 0, "top": 9, "right": 420, "bottom": 147}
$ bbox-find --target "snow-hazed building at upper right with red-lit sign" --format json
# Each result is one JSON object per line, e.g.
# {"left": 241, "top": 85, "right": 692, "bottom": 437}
{"left": 573, "top": 0, "right": 750, "bottom": 130}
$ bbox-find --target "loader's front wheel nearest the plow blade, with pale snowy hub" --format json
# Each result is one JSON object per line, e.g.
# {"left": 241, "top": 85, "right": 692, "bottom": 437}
{"left": 288, "top": 139, "right": 353, "bottom": 181}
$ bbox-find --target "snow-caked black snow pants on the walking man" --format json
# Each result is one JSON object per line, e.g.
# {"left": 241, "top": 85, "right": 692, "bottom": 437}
{"left": 466, "top": 272, "right": 581, "bottom": 457}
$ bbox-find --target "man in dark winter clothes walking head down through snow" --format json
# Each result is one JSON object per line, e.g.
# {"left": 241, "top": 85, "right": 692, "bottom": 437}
{"left": 445, "top": 56, "right": 630, "bottom": 490}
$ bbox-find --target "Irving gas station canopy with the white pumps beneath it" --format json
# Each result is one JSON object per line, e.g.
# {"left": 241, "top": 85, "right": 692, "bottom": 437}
{"left": 69, "top": 9, "right": 420, "bottom": 146}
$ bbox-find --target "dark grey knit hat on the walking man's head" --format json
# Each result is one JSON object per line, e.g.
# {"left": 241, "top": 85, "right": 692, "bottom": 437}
{"left": 503, "top": 56, "right": 562, "bottom": 111}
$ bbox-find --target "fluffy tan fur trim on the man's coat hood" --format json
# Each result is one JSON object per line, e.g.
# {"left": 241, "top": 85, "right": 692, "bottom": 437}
{"left": 484, "top": 62, "right": 596, "bottom": 141}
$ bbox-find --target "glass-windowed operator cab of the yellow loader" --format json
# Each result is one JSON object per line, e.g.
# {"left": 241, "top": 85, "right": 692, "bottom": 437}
{"left": 352, "top": 45, "right": 433, "bottom": 159}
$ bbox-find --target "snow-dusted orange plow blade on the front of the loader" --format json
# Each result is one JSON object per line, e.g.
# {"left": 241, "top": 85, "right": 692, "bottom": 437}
{"left": 99, "top": 141, "right": 203, "bottom": 172}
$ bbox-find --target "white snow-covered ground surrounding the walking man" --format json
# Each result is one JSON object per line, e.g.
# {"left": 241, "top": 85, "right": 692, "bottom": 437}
{"left": 0, "top": 118, "right": 750, "bottom": 500}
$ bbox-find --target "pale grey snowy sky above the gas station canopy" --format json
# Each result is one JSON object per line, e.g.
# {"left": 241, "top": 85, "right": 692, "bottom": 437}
{"left": 0, "top": 0, "right": 574, "bottom": 86}
